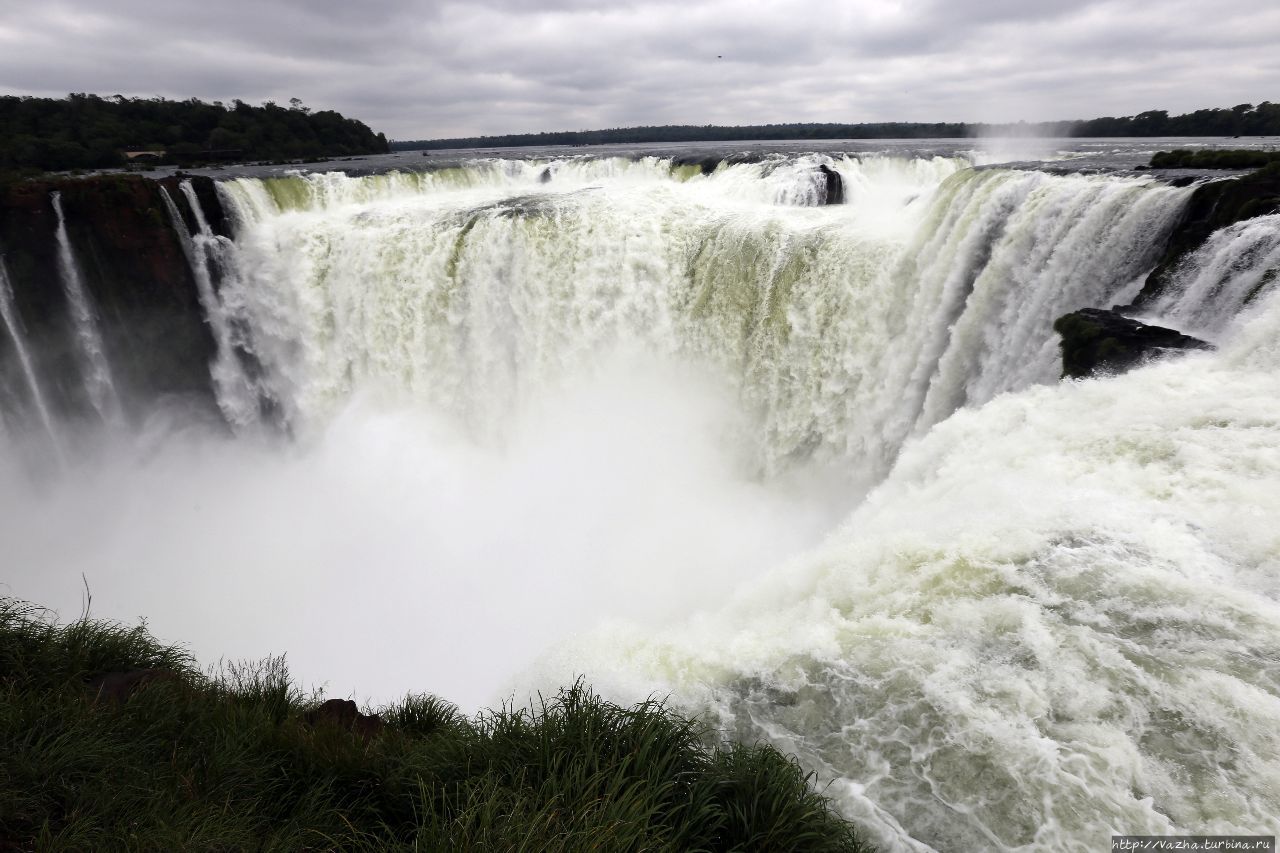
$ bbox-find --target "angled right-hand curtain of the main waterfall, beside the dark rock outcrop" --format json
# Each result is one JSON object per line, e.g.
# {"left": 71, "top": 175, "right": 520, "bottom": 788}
{"left": 906, "top": 172, "right": 1189, "bottom": 434}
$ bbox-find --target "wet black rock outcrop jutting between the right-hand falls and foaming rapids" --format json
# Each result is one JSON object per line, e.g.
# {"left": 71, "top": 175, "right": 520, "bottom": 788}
{"left": 1053, "top": 303, "right": 1213, "bottom": 379}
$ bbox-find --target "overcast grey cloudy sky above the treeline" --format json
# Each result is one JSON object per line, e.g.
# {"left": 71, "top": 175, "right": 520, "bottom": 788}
{"left": 0, "top": 0, "right": 1280, "bottom": 140}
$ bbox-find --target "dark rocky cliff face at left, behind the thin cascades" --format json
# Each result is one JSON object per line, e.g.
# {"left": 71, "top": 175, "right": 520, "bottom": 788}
{"left": 0, "top": 175, "right": 225, "bottom": 427}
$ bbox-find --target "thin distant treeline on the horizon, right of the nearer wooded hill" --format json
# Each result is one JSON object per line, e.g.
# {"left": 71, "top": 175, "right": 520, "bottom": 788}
{"left": 392, "top": 101, "right": 1280, "bottom": 151}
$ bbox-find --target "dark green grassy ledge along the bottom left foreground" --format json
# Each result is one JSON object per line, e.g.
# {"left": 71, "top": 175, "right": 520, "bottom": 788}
{"left": 0, "top": 598, "right": 872, "bottom": 853}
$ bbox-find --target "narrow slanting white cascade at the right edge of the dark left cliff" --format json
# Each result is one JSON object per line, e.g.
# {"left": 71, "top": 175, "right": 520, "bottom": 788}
{"left": 160, "top": 181, "right": 259, "bottom": 427}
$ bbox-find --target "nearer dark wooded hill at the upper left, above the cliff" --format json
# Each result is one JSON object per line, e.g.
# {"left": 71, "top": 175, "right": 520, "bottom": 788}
{"left": 0, "top": 93, "right": 388, "bottom": 172}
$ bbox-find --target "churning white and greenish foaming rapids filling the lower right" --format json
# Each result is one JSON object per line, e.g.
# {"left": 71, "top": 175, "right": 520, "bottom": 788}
{"left": 544, "top": 289, "right": 1280, "bottom": 850}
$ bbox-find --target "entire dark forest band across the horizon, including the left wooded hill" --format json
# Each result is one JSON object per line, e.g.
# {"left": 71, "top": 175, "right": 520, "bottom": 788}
{"left": 0, "top": 93, "right": 1280, "bottom": 173}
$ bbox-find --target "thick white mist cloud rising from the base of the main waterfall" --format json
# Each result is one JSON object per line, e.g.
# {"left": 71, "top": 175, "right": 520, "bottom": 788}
{"left": 0, "top": 356, "right": 847, "bottom": 711}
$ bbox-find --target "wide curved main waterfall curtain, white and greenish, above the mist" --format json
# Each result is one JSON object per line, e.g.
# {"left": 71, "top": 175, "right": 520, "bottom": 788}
{"left": 224, "top": 158, "right": 1189, "bottom": 484}
